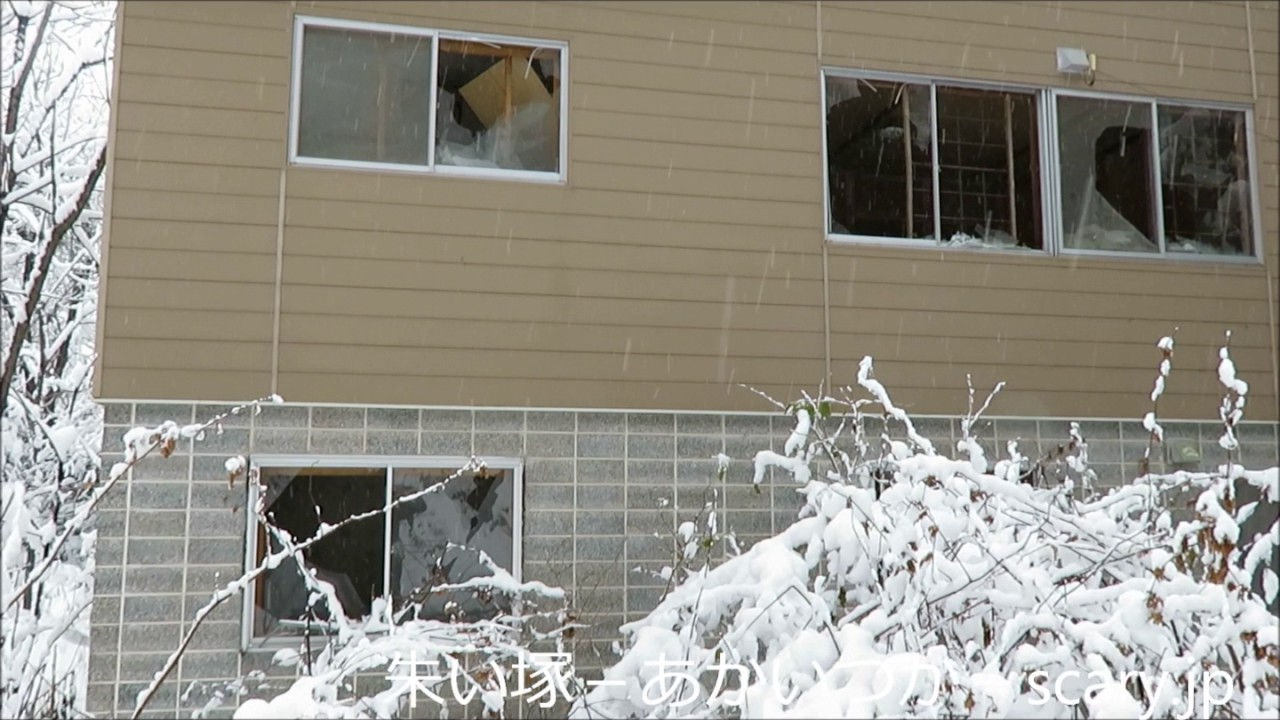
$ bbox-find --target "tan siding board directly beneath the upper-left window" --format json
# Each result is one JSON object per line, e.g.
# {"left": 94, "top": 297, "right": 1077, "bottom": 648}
{"left": 287, "top": 170, "right": 818, "bottom": 227}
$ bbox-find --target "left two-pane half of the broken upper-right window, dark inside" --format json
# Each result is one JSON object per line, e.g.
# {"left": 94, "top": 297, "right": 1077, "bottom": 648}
{"left": 826, "top": 76, "right": 1044, "bottom": 250}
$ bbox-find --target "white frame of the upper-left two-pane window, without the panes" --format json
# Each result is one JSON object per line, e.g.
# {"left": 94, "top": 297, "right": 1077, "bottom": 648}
{"left": 288, "top": 15, "right": 568, "bottom": 184}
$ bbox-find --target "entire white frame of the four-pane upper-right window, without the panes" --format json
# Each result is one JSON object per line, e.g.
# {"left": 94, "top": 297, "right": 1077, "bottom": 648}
{"left": 819, "top": 67, "right": 1263, "bottom": 265}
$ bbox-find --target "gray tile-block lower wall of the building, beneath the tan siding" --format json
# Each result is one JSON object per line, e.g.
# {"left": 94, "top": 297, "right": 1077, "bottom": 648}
{"left": 88, "top": 404, "right": 1277, "bottom": 717}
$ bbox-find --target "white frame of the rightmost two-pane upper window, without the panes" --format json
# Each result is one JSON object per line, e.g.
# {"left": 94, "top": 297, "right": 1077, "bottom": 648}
{"left": 1050, "top": 88, "right": 1262, "bottom": 265}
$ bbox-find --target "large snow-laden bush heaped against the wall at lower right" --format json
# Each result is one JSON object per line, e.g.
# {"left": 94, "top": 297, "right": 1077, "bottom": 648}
{"left": 575, "top": 338, "right": 1280, "bottom": 717}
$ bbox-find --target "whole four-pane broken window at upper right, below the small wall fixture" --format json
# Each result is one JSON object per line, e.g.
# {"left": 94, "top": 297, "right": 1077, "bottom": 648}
{"left": 823, "top": 70, "right": 1257, "bottom": 261}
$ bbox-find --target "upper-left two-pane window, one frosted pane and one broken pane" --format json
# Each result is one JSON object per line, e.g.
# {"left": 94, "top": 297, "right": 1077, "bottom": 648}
{"left": 291, "top": 18, "right": 566, "bottom": 179}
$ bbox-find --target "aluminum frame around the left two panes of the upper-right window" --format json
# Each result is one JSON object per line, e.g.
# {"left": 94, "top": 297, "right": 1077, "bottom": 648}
{"left": 819, "top": 65, "right": 1052, "bottom": 258}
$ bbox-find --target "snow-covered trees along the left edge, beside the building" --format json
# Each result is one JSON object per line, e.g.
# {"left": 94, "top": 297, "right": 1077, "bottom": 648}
{"left": 0, "top": 0, "right": 114, "bottom": 717}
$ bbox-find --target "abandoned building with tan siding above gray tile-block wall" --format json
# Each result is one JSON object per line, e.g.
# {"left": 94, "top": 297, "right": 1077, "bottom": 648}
{"left": 90, "top": 0, "right": 1280, "bottom": 716}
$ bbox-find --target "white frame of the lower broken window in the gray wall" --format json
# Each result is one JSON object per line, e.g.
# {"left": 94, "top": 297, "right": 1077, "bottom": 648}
{"left": 241, "top": 455, "right": 525, "bottom": 652}
